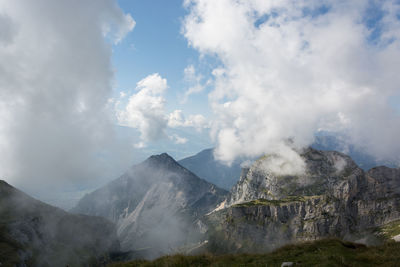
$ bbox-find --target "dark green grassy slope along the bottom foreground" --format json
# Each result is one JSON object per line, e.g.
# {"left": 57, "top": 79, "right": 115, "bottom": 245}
{"left": 110, "top": 239, "right": 400, "bottom": 267}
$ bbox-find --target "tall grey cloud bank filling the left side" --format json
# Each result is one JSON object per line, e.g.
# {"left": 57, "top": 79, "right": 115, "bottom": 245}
{"left": 0, "top": 0, "right": 135, "bottom": 193}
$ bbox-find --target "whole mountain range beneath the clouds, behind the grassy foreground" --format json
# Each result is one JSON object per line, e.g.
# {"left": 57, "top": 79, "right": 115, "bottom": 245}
{"left": 0, "top": 148, "right": 400, "bottom": 266}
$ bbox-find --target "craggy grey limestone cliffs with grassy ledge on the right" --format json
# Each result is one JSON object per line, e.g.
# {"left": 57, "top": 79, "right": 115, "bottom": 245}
{"left": 204, "top": 149, "right": 400, "bottom": 252}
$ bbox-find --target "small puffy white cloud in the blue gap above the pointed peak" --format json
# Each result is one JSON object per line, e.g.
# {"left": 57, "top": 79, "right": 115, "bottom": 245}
{"left": 117, "top": 73, "right": 168, "bottom": 144}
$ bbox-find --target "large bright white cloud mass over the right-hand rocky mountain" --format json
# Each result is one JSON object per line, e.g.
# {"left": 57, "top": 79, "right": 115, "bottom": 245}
{"left": 183, "top": 0, "right": 400, "bottom": 165}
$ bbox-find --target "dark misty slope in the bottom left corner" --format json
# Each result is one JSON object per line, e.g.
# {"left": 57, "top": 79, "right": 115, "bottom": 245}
{"left": 0, "top": 180, "right": 120, "bottom": 266}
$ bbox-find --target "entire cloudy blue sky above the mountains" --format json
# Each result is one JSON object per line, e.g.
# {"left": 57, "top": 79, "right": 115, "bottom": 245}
{"left": 0, "top": 0, "right": 400, "bottom": 209}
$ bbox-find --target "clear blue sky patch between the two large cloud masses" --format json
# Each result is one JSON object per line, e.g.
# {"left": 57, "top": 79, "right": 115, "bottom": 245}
{"left": 113, "top": 0, "right": 207, "bottom": 112}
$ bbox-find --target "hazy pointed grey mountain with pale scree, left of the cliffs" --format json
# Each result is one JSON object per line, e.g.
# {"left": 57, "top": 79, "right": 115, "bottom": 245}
{"left": 73, "top": 153, "right": 227, "bottom": 258}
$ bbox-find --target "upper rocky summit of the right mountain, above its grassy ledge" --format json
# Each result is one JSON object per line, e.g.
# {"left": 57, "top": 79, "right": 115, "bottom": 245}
{"left": 228, "top": 148, "right": 363, "bottom": 205}
